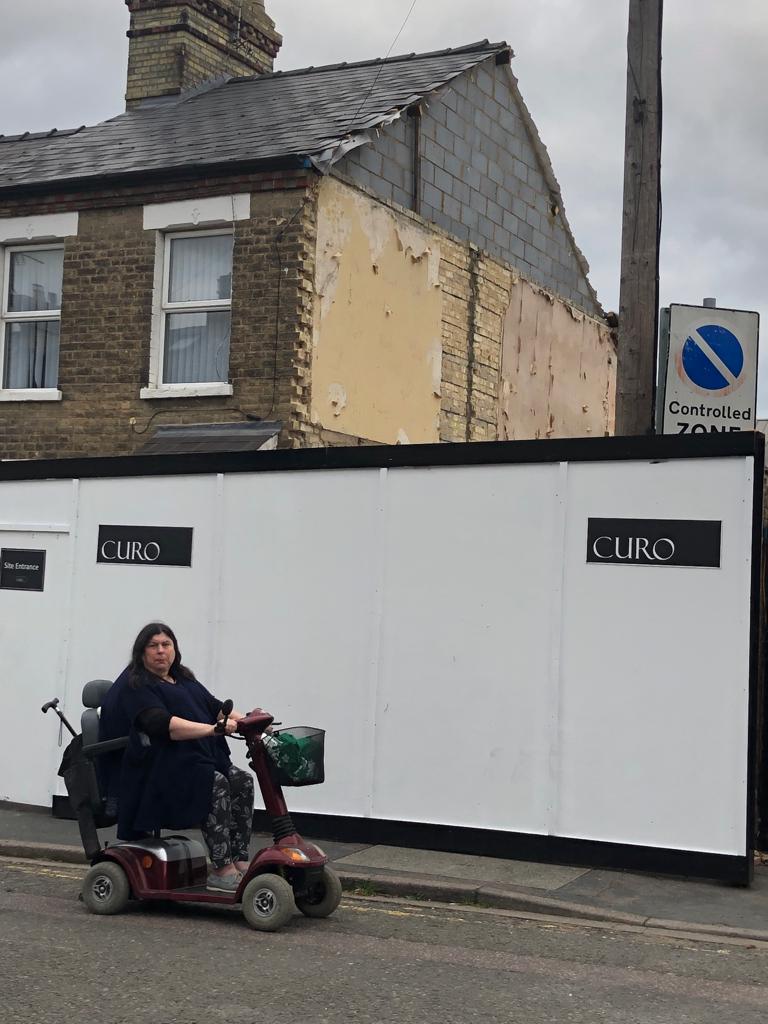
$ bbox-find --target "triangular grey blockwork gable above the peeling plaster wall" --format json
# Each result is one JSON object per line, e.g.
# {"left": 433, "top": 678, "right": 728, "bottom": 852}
{"left": 338, "top": 60, "right": 602, "bottom": 316}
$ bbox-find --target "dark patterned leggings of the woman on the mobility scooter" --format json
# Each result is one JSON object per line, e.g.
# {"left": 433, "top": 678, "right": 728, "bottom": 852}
{"left": 200, "top": 765, "right": 253, "bottom": 867}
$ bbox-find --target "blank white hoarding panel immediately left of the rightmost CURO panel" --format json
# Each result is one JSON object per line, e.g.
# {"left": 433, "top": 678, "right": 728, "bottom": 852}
{"left": 373, "top": 465, "right": 559, "bottom": 833}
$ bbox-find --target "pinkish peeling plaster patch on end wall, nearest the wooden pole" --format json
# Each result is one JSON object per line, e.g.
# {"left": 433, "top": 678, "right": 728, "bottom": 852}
{"left": 499, "top": 279, "right": 615, "bottom": 440}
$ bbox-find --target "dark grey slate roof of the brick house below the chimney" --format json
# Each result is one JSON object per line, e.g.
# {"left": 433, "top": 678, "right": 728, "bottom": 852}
{"left": 0, "top": 40, "right": 509, "bottom": 188}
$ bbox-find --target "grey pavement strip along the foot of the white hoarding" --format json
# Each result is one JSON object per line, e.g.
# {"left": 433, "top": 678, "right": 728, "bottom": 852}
{"left": 0, "top": 803, "right": 768, "bottom": 942}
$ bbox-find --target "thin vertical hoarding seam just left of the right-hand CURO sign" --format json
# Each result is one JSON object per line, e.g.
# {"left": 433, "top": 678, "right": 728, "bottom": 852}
{"left": 547, "top": 462, "right": 568, "bottom": 836}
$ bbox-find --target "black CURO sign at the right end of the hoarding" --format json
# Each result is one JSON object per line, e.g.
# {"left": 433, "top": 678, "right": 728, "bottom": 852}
{"left": 587, "top": 519, "right": 722, "bottom": 568}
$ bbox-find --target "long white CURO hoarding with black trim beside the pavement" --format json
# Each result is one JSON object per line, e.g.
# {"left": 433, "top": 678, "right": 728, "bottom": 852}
{"left": 0, "top": 434, "right": 763, "bottom": 879}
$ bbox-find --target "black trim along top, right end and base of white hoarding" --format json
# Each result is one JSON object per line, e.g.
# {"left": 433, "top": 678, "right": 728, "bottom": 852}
{"left": 9, "top": 432, "right": 768, "bottom": 885}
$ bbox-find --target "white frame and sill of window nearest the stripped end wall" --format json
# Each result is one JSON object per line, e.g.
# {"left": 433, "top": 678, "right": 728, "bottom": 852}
{"left": 139, "top": 225, "right": 234, "bottom": 398}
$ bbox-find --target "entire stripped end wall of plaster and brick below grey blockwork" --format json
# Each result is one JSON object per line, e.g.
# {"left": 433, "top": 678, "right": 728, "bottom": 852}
{"left": 309, "top": 178, "right": 615, "bottom": 444}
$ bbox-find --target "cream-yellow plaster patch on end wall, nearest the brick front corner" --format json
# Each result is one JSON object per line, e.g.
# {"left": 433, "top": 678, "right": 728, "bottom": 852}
{"left": 310, "top": 178, "right": 442, "bottom": 443}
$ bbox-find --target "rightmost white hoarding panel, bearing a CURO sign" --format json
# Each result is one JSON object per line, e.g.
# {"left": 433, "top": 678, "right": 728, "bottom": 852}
{"left": 556, "top": 459, "right": 752, "bottom": 854}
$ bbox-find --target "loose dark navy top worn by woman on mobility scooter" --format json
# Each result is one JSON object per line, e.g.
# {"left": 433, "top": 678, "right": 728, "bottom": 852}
{"left": 101, "top": 670, "right": 231, "bottom": 840}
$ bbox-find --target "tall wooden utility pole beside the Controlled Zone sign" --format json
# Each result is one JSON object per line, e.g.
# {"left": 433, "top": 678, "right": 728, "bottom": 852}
{"left": 615, "top": 0, "right": 664, "bottom": 434}
